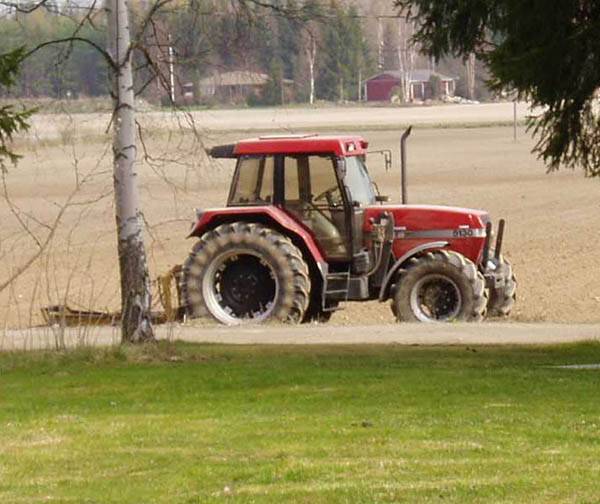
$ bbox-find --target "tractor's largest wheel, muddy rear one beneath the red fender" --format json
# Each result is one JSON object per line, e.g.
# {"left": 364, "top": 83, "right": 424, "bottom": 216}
{"left": 181, "top": 222, "right": 310, "bottom": 325}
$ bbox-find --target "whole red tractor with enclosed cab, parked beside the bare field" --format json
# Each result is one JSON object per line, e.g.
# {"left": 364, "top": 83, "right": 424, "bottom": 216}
{"left": 181, "top": 129, "right": 516, "bottom": 324}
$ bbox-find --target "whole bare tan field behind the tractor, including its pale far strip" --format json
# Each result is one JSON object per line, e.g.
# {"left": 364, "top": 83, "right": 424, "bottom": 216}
{"left": 0, "top": 104, "right": 600, "bottom": 328}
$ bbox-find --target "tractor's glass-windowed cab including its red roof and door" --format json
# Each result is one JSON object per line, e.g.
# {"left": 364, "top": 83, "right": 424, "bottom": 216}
{"left": 221, "top": 135, "right": 378, "bottom": 265}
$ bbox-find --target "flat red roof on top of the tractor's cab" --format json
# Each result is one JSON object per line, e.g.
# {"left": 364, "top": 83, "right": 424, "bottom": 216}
{"left": 209, "top": 134, "right": 369, "bottom": 158}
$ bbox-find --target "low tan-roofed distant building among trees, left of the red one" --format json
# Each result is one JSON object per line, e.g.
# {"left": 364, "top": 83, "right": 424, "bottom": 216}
{"left": 198, "top": 70, "right": 294, "bottom": 103}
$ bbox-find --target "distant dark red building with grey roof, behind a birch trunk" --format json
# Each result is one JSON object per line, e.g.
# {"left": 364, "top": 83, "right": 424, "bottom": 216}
{"left": 365, "top": 70, "right": 456, "bottom": 101}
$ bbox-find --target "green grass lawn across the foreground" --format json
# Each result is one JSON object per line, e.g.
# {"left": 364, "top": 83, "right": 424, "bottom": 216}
{"left": 0, "top": 343, "right": 600, "bottom": 503}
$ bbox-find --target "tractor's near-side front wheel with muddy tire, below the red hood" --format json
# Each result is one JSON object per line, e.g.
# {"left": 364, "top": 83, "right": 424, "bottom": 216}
{"left": 392, "top": 250, "right": 488, "bottom": 322}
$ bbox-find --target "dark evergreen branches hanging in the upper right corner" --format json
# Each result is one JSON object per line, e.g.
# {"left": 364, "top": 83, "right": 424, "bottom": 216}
{"left": 396, "top": 0, "right": 600, "bottom": 176}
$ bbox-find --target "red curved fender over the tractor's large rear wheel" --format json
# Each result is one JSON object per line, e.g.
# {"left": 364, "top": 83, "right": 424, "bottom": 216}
{"left": 188, "top": 206, "right": 328, "bottom": 282}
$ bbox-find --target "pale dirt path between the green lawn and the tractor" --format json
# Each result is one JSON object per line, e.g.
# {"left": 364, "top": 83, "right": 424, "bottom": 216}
{"left": 0, "top": 322, "right": 600, "bottom": 350}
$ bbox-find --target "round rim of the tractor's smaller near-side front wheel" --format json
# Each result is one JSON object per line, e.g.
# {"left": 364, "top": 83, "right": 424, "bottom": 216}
{"left": 410, "top": 274, "right": 462, "bottom": 322}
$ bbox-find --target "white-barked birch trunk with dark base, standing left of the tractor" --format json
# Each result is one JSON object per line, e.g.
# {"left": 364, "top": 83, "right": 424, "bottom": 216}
{"left": 106, "top": 0, "right": 154, "bottom": 343}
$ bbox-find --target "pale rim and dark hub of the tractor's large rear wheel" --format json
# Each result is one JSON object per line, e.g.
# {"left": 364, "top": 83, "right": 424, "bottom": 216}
{"left": 202, "top": 250, "right": 279, "bottom": 325}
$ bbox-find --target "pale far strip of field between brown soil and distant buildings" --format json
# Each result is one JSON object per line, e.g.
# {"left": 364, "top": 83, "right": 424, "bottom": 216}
{"left": 23, "top": 102, "right": 532, "bottom": 140}
